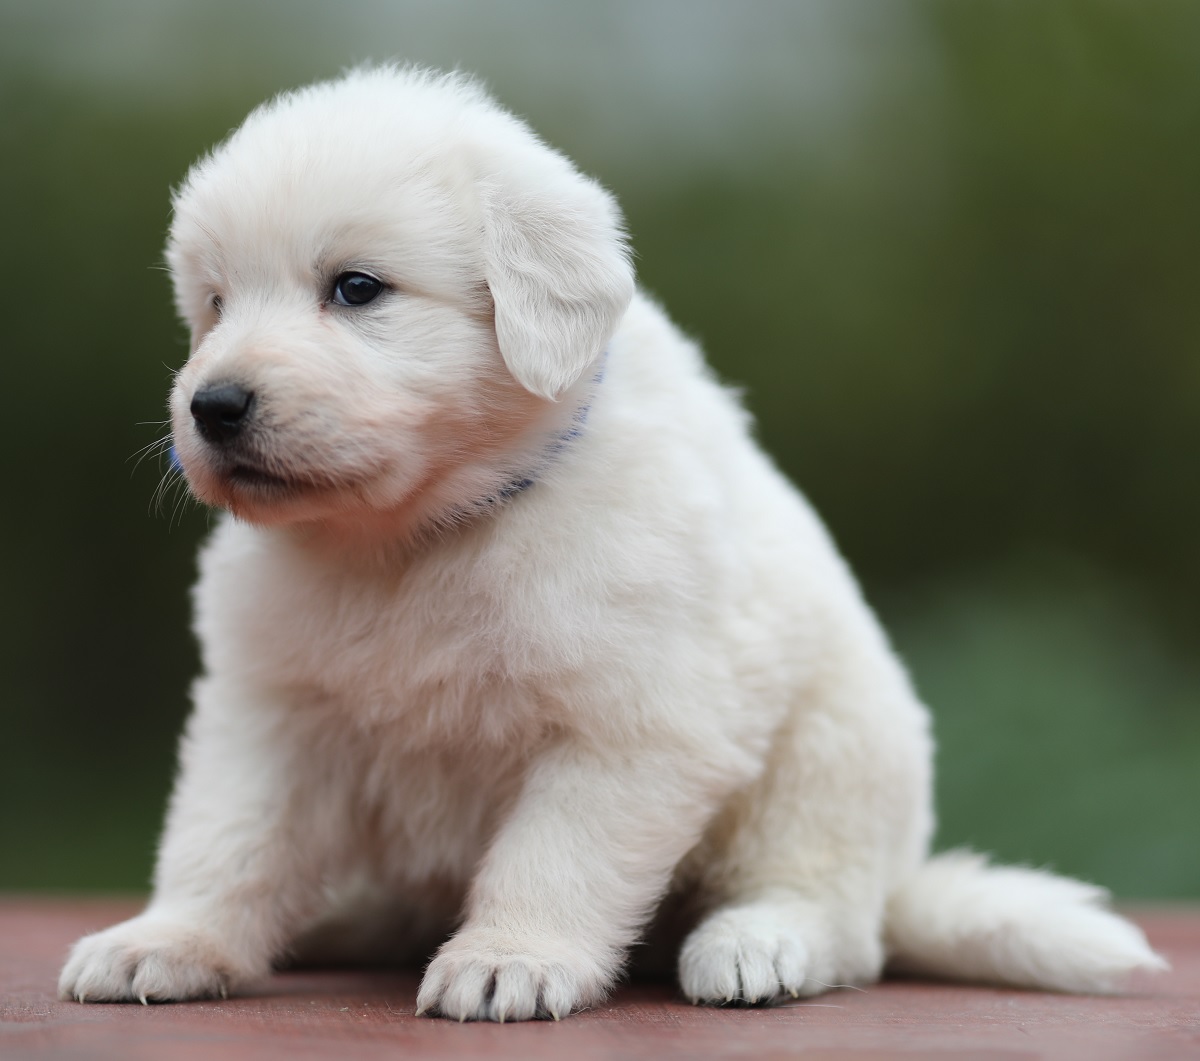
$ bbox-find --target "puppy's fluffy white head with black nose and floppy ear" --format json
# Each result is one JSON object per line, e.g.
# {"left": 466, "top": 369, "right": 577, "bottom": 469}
{"left": 167, "top": 67, "right": 632, "bottom": 523}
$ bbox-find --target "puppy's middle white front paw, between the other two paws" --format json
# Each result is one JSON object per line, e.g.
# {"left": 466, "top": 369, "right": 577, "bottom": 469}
{"left": 416, "top": 928, "right": 610, "bottom": 1023}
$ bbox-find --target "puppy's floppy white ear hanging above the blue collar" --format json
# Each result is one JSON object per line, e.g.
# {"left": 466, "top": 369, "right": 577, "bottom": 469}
{"left": 482, "top": 169, "right": 634, "bottom": 401}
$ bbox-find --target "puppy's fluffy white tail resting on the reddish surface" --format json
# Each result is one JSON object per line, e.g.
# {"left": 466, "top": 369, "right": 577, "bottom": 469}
{"left": 887, "top": 851, "right": 1168, "bottom": 994}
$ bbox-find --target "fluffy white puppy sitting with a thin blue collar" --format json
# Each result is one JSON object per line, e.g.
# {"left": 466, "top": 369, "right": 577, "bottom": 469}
{"left": 60, "top": 67, "right": 1162, "bottom": 1020}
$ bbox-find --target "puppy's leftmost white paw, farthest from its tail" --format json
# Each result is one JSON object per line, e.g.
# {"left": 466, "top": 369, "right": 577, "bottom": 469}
{"left": 59, "top": 915, "right": 252, "bottom": 1005}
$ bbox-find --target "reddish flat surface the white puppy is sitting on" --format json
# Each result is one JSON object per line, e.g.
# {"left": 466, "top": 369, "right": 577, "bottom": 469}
{"left": 0, "top": 899, "right": 1200, "bottom": 1061}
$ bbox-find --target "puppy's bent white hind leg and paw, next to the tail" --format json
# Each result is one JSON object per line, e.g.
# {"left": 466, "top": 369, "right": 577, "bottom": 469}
{"left": 679, "top": 625, "right": 931, "bottom": 1003}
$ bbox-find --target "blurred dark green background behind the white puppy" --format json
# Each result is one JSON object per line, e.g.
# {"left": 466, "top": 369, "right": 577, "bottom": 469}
{"left": 0, "top": 0, "right": 1200, "bottom": 899}
